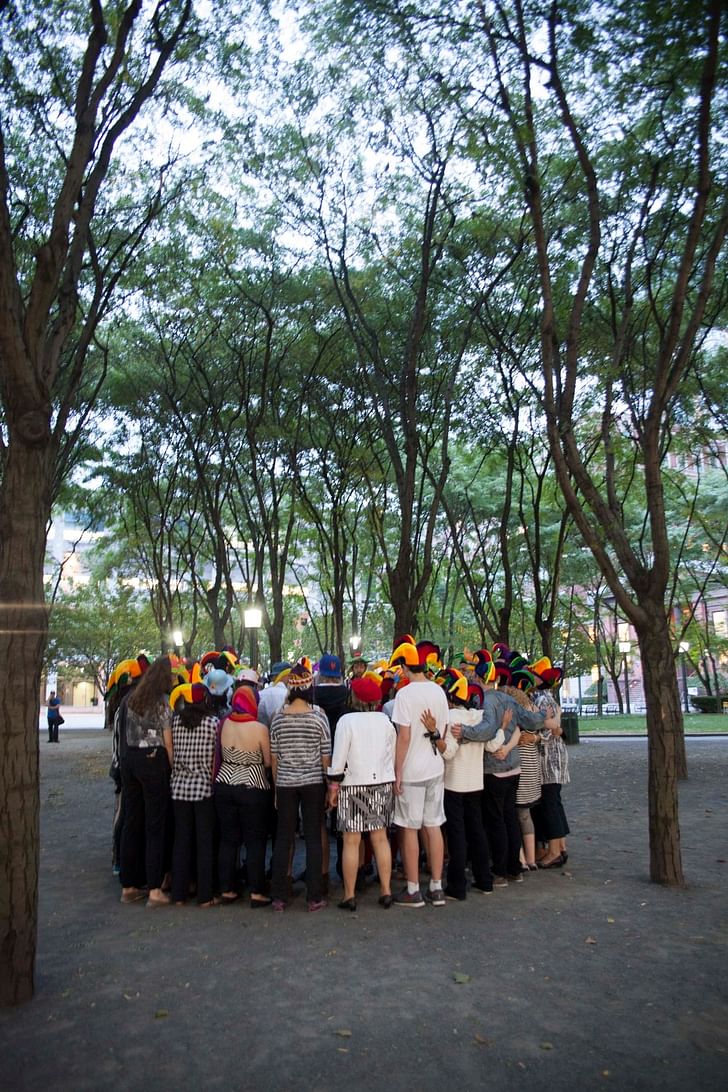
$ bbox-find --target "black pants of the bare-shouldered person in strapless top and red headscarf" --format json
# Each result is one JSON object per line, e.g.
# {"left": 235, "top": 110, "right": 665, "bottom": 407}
{"left": 215, "top": 781, "right": 273, "bottom": 894}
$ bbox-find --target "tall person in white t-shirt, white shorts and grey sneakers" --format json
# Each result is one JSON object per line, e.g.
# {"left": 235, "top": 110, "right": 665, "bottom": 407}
{"left": 390, "top": 642, "right": 449, "bottom": 906}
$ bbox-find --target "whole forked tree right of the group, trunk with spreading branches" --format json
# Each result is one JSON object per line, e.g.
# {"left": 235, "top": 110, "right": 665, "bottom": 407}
{"left": 469, "top": 0, "right": 728, "bottom": 886}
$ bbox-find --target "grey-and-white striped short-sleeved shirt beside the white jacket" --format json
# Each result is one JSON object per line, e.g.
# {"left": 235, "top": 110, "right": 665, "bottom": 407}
{"left": 271, "top": 705, "right": 331, "bottom": 787}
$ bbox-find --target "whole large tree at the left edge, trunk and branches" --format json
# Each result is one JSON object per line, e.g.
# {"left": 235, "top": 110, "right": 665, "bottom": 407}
{"left": 0, "top": 0, "right": 192, "bottom": 1005}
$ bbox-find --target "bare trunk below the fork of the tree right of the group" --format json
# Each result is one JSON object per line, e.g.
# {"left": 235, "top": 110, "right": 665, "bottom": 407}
{"left": 637, "top": 605, "right": 684, "bottom": 887}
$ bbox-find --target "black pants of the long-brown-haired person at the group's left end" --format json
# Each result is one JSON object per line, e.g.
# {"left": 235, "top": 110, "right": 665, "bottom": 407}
{"left": 121, "top": 747, "right": 169, "bottom": 889}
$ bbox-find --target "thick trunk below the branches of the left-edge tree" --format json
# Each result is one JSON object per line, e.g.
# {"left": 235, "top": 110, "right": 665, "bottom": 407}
{"left": 0, "top": 423, "right": 50, "bottom": 1006}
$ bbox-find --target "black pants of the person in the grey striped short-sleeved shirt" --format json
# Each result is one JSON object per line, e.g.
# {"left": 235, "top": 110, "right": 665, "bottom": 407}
{"left": 271, "top": 782, "right": 326, "bottom": 902}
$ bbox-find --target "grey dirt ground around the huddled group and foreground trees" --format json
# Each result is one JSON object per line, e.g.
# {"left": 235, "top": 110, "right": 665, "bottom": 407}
{"left": 0, "top": 732, "right": 728, "bottom": 1092}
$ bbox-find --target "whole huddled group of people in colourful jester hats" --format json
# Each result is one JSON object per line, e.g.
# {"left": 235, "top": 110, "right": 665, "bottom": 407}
{"left": 106, "top": 634, "right": 569, "bottom": 913}
